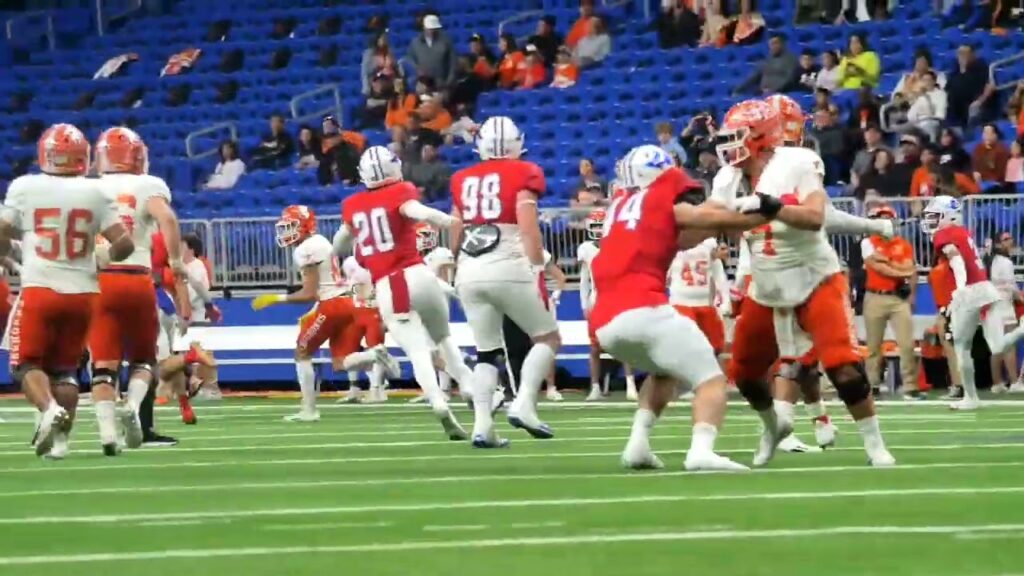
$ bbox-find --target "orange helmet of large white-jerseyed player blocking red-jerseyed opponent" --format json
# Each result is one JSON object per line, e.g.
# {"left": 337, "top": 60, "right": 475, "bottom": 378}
{"left": 715, "top": 100, "right": 782, "bottom": 166}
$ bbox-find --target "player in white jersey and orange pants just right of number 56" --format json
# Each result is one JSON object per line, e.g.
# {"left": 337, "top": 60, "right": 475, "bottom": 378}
{"left": 89, "top": 127, "right": 188, "bottom": 456}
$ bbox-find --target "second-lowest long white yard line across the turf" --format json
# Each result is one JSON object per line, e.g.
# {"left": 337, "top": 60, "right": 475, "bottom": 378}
{"left": 0, "top": 486, "right": 1024, "bottom": 526}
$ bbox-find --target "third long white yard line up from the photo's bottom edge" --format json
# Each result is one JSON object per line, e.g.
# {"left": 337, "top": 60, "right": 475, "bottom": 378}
{"left": 0, "top": 453, "right": 1024, "bottom": 501}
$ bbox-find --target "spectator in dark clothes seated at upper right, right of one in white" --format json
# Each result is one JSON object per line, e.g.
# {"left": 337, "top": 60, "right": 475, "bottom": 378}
{"left": 946, "top": 44, "right": 996, "bottom": 127}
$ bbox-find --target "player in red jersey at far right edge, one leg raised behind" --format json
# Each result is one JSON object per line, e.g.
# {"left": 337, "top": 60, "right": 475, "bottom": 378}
{"left": 921, "top": 196, "right": 1024, "bottom": 410}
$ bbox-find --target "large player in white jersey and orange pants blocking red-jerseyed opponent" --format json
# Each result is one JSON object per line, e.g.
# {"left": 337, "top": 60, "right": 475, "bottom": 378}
{"left": 717, "top": 100, "right": 895, "bottom": 465}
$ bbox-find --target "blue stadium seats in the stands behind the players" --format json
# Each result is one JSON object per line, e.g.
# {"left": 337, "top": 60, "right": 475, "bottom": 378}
{"left": 0, "top": 0, "right": 1024, "bottom": 224}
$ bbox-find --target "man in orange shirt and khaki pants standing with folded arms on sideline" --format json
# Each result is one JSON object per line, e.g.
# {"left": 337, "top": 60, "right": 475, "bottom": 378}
{"left": 860, "top": 204, "right": 918, "bottom": 393}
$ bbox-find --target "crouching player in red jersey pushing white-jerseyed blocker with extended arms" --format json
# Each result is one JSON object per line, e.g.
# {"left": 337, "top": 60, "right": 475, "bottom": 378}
{"left": 589, "top": 146, "right": 781, "bottom": 470}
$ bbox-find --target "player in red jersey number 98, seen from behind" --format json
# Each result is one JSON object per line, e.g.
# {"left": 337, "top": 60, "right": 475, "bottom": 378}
{"left": 452, "top": 116, "right": 562, "bottom": 438}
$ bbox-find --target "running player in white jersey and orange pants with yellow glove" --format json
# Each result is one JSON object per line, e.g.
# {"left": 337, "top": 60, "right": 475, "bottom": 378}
{"left": 252, "top": 205, "right": 398, "bottom": 422}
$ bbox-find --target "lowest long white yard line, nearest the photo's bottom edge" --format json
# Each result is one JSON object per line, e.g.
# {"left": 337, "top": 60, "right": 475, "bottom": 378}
{"left": 0, "top": 524, "right": 1024, "bottom": 566}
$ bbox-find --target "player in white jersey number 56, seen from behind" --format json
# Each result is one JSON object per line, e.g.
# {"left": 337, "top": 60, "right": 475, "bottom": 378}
{"left": 0, "top": 124, "right": 134, "bottom": 458}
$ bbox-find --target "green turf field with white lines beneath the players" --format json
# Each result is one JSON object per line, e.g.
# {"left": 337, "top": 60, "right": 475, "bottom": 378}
{"left": 0, "top": 397, "right": 1024, "bottom": 576}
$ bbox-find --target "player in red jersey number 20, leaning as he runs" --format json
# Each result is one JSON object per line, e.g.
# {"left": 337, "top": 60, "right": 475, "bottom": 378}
{"left": 334, "top": 146, "right": 489, "bottom": 440}
